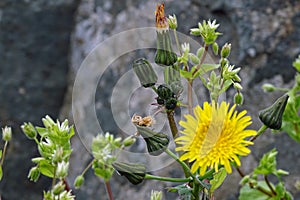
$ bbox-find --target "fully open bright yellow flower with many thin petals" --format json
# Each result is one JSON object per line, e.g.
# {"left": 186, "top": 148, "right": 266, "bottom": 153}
{"left": 175, "top": 102, "right": 257, "bottom": 175}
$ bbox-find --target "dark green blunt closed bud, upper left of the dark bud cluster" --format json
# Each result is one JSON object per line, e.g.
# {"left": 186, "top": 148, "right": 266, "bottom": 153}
{"left": 133, "top": 58, "right": 157, "bottom": 88}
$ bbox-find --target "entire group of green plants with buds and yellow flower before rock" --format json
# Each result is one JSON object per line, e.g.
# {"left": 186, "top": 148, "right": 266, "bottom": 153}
{"left": 0, "top": 1, "right": 300, "bottom": 200}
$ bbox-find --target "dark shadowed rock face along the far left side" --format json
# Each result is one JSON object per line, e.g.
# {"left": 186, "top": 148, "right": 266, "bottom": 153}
{"left": 0, "top": 0, "right": 78, "bottom": 199}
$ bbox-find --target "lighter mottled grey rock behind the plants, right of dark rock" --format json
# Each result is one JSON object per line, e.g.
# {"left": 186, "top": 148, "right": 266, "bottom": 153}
{"left": 70, "top": 0, "right": 300, "bottom": 200}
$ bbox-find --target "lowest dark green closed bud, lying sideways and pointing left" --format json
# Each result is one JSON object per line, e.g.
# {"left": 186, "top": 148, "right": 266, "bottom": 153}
{"left": 112, "top": 162, "right": 146, "bottom": 185}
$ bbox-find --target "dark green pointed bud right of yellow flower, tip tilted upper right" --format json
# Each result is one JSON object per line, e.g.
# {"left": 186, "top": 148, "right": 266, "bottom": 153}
{"left": 259, "top": 95, "right": 289, "bottom": 130}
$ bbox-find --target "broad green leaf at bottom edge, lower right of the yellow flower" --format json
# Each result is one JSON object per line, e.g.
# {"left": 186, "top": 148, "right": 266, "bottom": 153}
{"left": 239, "top": 181, "right": 271, "bottom": 200}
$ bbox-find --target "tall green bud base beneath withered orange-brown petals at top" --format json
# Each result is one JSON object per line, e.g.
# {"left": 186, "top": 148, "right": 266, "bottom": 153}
{"left": 155, "top": 30, "right": 177, "bottom": 66}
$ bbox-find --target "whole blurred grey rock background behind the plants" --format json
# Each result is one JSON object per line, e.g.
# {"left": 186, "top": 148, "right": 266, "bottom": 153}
{"left": 0, "top": 0, "right": 300, "bottom": 200}
